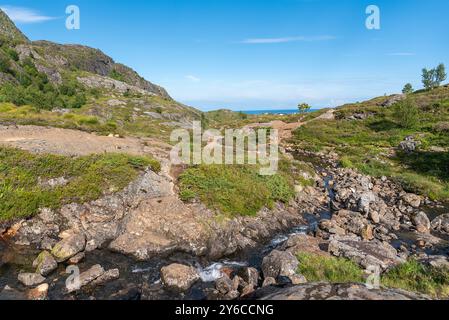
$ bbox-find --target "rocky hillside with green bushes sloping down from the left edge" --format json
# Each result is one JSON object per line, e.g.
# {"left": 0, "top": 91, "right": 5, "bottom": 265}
{"left": 0, "top": 12, "right": 201, "bottom": 138}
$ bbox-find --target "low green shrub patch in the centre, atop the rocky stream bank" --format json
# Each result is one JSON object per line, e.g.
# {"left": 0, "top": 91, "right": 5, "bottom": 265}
{"left": 179, "top": 165, "right": 294, "bottom": 216}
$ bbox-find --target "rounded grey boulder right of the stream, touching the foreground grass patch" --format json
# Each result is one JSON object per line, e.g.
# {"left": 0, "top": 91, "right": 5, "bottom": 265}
{"left": 262, "top": 250, "right": 299, "bottom": 279}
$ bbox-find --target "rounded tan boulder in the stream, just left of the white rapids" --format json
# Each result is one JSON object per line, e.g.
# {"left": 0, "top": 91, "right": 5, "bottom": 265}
{"left": 161, "top": 264, "right": 200, "bottom": 292}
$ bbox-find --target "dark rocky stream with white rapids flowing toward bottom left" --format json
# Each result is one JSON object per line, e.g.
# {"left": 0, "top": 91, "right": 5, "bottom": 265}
{"left": 0, "top": 158, "right": 449, "bottom": 300}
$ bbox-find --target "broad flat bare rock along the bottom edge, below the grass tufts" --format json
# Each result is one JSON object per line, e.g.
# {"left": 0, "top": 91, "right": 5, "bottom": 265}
{"left": 254, "top": 283, "right": 430, "bottom": 300}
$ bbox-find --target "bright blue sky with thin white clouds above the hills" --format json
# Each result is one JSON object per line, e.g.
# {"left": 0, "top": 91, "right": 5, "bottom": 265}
{"left": 0, "top": 0, "right": 449, "bottom": 110}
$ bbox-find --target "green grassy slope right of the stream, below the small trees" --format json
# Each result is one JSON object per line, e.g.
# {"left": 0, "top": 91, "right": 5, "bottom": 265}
{"left": 292, "top": 87, "right": 449, "bottom": 200}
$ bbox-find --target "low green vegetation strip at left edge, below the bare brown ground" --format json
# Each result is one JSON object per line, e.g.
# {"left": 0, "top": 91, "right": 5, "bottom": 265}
{"left": 0, "top": 147, "right": 160, "bottom": 221}
